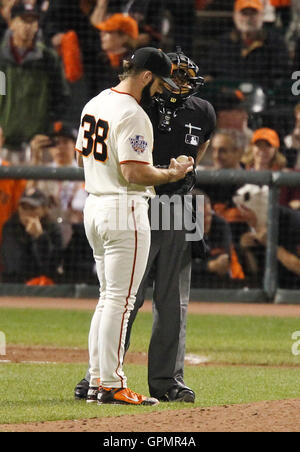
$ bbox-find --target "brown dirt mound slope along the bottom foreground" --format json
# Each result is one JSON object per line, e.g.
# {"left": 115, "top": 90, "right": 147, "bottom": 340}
{"left": 0, "top": 400, "right": 300, "bottom": 432}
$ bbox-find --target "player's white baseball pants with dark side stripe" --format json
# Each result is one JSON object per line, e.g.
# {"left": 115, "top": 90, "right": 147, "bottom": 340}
{"left": 84, "top": 195, "right": 150, "bottom": 388}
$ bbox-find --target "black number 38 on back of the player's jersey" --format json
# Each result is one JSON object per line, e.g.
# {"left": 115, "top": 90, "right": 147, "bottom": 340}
{"left": 81, "top": 115, "right": 109, "bottom": 163}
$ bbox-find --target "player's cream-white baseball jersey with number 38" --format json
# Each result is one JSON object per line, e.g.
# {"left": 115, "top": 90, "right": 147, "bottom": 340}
{"left": 76, "top": 89, "right": 154, "bottom": 197}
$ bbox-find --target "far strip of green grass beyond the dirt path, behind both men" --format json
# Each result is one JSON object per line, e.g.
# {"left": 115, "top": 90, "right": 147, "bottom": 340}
{"left": 0, "top": 309, "right": 300, "bottom": 365}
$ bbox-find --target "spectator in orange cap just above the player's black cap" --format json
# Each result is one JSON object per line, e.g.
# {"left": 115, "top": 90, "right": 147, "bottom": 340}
{"left": 93, "top": 13, "right": 138, "bottom": 94}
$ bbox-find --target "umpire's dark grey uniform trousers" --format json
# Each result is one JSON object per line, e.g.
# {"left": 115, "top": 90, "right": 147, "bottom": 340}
{"left": 125, "top": 200, "right": 191, "bottom": 397}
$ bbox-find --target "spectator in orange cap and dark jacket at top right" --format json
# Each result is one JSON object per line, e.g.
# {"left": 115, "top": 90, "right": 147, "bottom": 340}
{"left": 206, "top": 0, "right": 289, "bottom": 88}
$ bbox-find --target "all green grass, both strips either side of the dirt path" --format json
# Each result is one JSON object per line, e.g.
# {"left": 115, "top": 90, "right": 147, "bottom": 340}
{"left": 0, "top": 309, "right": 300, "bottom": 430}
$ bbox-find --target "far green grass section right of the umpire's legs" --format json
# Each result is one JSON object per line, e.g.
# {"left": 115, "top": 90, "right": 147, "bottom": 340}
{"left": 187, "top": 316, "right": 300, "bottom": 365}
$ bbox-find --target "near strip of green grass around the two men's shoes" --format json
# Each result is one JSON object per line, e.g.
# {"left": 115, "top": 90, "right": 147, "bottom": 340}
{"left": 0, "top": 364, "right": 300, "bottom": 431}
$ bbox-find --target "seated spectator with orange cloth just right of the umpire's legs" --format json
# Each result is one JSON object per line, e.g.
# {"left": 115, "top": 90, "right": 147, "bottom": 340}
{"left": 192, "top": 189, "right": 244, "bottom": 288}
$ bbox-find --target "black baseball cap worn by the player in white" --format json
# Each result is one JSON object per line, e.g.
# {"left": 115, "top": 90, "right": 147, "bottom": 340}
{"left": 131, "top": 47, "right": 179, "bottom": 90}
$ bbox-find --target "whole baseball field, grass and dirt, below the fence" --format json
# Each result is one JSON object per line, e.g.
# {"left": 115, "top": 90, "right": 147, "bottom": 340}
{"left": 0, "top": 297, "right": 300, "bottom": 432}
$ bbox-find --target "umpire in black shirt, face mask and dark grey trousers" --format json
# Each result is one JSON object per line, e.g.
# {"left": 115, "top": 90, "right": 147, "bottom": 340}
{"left": 75, "top": 48, "right": 216, "bottom": 402}
